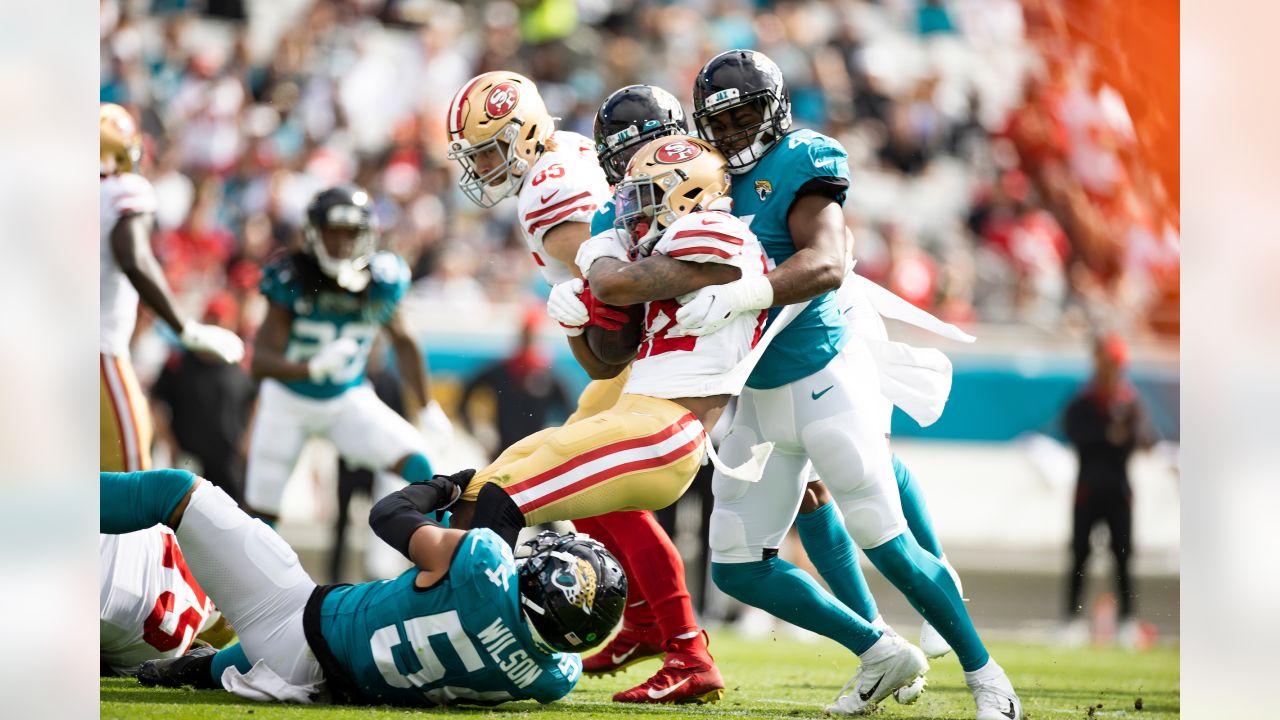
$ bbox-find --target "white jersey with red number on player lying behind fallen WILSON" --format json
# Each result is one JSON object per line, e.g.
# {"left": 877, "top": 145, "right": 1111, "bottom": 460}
{"left": 99, "top": 525, "right": 219, "bottom": 674}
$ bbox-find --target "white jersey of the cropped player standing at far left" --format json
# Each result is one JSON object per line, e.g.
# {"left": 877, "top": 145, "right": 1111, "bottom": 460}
{"left": 99, "top": 173, "right": 156, "bottom": 357}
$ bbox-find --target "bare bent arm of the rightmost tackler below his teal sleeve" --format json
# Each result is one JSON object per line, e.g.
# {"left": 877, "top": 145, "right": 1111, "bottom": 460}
{"left": 768, "top": 195, "right": 850, "bottom": 306}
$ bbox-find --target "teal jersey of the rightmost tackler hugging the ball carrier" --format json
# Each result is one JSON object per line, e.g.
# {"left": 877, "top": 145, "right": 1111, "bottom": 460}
{"left": 731, "top": 129, "right": 849, "bottom": 389}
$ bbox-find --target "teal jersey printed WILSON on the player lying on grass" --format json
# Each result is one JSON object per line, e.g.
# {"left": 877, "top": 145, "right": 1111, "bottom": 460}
{"left": 320, "top": 529, "right": 582, "bottom": 707}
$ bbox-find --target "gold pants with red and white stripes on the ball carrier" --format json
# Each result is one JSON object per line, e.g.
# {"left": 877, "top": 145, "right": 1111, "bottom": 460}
{"left": 463, "top": 395, "right": 707, "bottom": 525}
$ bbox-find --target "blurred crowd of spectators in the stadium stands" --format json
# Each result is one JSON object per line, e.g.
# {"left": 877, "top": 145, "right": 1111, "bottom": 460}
{"left": 101, "top": 0, "right": 1179, "bottom": 381}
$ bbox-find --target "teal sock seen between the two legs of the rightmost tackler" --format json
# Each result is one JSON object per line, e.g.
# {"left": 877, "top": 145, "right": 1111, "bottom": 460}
{"left": 796, "top": 502, "right": 879, "bottom": 621}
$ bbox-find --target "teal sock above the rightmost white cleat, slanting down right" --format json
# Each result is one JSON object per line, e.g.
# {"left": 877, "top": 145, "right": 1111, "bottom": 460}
{"left": 865, "top": 533, "right": 991, "bottom": 673}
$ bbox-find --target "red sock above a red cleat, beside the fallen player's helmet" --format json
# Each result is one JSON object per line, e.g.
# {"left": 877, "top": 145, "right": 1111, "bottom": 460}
{"left": 573, "top": 510, "right": 698, "bottom": 642}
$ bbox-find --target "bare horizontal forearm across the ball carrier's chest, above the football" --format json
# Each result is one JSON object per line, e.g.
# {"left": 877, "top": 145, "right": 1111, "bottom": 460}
{"left": 588, "top": 254, "right": 742, "bottom": 305}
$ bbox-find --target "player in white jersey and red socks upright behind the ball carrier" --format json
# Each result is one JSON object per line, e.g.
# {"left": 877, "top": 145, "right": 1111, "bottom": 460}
{"left": 447, "top": 72, "right": 724, "bottom": 702}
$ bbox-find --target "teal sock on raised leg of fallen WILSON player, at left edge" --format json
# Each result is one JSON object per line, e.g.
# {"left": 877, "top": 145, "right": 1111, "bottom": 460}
{"left": 97, "top": 470, "right": 196, "bottom": 536}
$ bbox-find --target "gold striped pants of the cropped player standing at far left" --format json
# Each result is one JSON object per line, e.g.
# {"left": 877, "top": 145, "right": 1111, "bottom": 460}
{"left": 97, "top": 354, "right": 151, "bottom": 473}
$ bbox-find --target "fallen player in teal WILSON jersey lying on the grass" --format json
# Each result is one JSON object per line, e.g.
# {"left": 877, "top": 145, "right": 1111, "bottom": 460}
{"left": 108, "top": 470, "right": 626, "bottom": 707}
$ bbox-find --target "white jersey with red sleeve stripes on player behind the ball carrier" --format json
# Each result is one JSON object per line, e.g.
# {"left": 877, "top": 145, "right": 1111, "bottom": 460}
{"left": 516, "top": 131, "right": 611, "bottom": 284}
